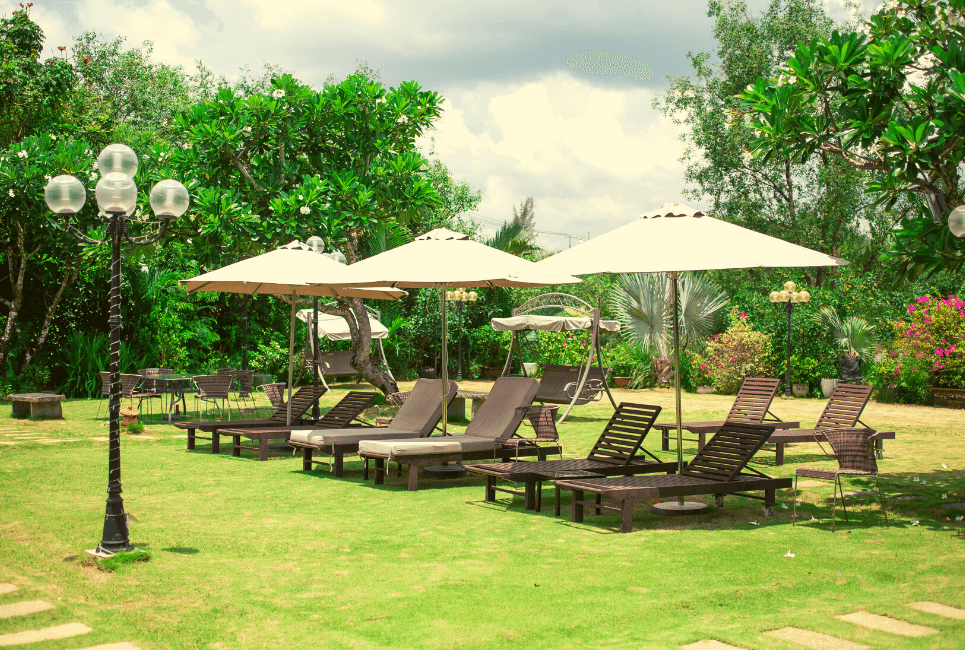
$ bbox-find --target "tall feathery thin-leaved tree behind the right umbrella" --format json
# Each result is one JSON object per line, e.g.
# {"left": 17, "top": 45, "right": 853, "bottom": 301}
{"left": 654, "top": 0, "right": 886, "bottom": 287}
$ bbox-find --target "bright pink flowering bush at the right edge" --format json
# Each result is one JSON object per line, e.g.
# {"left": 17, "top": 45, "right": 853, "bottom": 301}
{"left": 892, "top": 295, "right": 965, "bottom": 388}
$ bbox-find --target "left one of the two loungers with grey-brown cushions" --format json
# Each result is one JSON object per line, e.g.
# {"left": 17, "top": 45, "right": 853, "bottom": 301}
{"left": 288, "top": 379, "right": 459, "bottom": 477}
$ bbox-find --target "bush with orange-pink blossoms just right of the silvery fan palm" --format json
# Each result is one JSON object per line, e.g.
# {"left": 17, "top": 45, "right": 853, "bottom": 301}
{"left": 703, "top": 307, "right": 771, "bottom": 395}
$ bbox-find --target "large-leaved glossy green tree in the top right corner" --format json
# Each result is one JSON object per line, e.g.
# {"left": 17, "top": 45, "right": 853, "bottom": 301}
{"left": 739, "top": 0, "right": 965, "bottom": 277}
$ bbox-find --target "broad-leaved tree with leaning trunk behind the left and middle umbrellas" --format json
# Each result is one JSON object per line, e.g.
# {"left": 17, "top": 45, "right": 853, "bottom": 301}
{"left": 170, "top": 74, "right": 442, "bottom": 392}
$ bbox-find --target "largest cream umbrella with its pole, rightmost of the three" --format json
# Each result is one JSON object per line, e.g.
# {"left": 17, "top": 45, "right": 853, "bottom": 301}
{"left": 537, "top": 203, "right": 848, "bottom": 506}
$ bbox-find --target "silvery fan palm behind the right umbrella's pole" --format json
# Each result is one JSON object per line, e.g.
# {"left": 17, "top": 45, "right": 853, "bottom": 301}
{"left": 610, "top": 273, "right": 728, "bottom": 383}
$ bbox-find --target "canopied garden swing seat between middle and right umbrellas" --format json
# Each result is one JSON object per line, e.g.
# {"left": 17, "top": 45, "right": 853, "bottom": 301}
{"left": 492, "top": 293, "right": 620, "bottom": 424}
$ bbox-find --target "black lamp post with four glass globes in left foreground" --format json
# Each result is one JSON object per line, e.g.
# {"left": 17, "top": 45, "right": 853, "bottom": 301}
{"left": 44, "top": 144, "right": 189, "bottom": 557}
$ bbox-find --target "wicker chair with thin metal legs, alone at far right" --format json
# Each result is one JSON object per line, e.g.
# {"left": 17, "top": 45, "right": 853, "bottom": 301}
{"left": 791, "top": 429, "right": 888, "bottom": 532}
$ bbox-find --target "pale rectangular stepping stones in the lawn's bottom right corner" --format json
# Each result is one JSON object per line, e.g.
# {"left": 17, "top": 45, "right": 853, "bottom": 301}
{"left": 680, "top": 601, "right": 965, "bottom": 650}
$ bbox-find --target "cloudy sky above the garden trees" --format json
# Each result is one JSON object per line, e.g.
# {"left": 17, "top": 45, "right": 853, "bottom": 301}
{"left": 11, "top": 0, "right": 860, "bottom": 249}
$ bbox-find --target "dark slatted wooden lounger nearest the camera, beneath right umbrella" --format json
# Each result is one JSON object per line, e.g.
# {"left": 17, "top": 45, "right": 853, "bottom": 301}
{"left": 553, "top": 422, "right": 792, "bottom": 533}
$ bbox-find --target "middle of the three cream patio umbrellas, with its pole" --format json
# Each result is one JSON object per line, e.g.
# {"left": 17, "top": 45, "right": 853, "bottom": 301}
{"left": 330, "top": 228, "right": 580, "bottom": 435}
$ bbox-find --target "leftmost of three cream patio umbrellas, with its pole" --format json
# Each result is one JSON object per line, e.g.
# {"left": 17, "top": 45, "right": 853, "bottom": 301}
{"left": 180, "top": 241, "right": 406, "bottom": 425}
